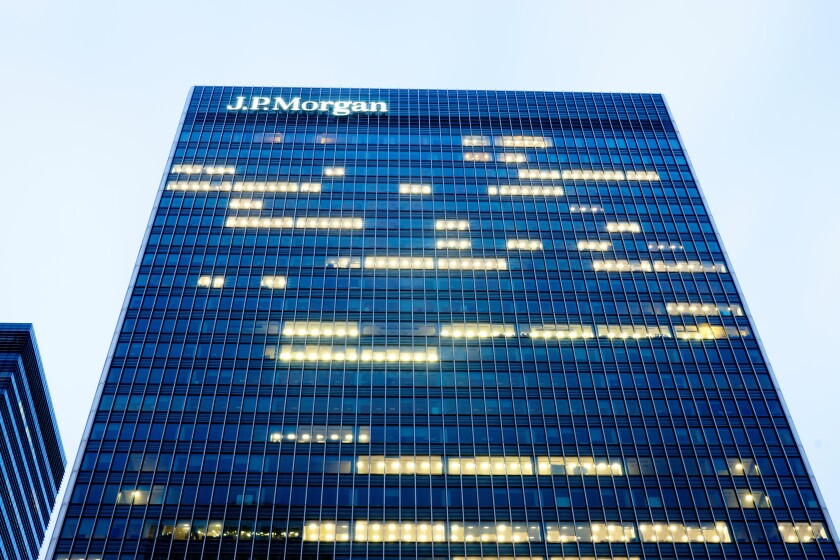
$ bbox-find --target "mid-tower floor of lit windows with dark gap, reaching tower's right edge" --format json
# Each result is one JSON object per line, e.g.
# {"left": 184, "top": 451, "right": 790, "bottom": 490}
{"left": 270, "top": 321, "right": 750, "bottom": 340}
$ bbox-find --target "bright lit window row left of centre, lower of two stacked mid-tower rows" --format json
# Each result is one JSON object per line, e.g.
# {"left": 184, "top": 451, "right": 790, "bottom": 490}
{"left": 280, "top": 346, "right": 438, "bottom": 363}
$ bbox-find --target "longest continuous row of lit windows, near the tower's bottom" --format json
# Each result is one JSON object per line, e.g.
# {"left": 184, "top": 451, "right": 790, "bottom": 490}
{"left": 303, "top": 521, "right": 728, "bottom": 543}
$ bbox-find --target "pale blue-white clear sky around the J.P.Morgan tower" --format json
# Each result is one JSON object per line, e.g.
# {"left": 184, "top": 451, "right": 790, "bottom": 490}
{"left": 0, "top": 0, "right": 840, "bottom": 552}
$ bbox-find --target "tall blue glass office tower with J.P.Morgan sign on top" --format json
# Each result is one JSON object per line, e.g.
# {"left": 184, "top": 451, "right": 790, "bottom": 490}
{"left": 49, "top": 87, "right": 838, "bottom": 560}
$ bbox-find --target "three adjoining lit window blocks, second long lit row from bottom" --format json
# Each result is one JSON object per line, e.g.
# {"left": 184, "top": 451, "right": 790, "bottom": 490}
{"left": 356, "top": 455, "right": 624, "bottom": 476}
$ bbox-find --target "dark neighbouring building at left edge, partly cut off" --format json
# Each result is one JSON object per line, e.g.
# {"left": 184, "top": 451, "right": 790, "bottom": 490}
{"left": 0, "top": 323, "right": 66, "bottom": 560}
